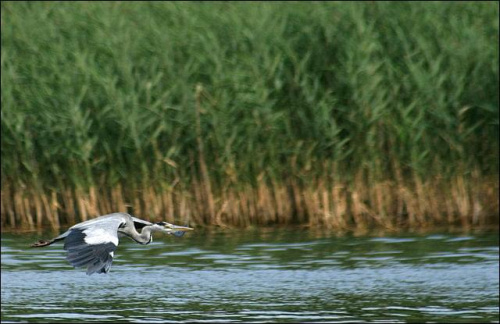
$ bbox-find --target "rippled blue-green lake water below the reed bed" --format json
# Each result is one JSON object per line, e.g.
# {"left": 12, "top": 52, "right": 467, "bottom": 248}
{"left": 1, "top": 229, "right": 499, "bottom": 323}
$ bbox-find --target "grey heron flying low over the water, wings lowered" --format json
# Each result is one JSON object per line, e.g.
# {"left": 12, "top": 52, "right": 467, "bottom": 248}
{"left": 31, "top": 213, "right": 193, "bottom": 275}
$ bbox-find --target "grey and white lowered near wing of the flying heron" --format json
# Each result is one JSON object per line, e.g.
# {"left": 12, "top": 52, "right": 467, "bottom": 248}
{"left": 64, "top": 213, "right": 128, "bottom": 275}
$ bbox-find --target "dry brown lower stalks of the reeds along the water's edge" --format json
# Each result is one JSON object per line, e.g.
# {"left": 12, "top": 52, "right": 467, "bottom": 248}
{"left": 1, "top": 177, "right": 499, "bottom": 230}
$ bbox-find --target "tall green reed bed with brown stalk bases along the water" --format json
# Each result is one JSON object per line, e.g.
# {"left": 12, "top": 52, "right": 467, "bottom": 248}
{"left": 0, "top": 1, "right": 499, "bottom": 230}
